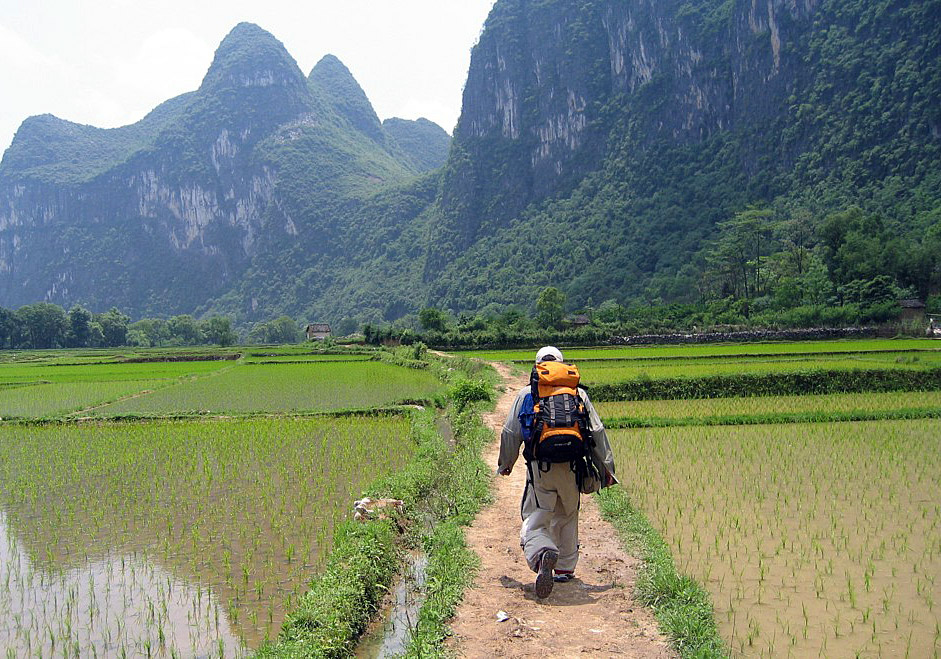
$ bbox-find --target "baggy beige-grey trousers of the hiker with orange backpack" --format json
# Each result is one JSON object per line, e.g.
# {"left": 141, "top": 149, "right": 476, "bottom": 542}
{"left": 520, "top": 462, "right": 580, "bottom": 572}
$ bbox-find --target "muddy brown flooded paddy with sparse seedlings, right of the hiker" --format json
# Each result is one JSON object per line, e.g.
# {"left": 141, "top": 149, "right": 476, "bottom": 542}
{"left": 609, "top": 422, "right": 941, "bottom": 657}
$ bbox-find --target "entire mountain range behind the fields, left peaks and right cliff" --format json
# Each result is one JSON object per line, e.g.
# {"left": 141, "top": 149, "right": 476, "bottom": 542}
{"left": 0, "top": 0, "right": 941, "bottom": 327}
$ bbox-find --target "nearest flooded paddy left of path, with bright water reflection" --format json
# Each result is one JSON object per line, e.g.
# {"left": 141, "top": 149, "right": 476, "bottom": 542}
{"left": 0, "top": 414, "right": 413, "bottom": 656}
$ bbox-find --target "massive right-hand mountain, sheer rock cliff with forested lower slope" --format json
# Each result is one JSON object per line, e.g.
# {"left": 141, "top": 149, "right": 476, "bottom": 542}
{"left": 424, "top": 0, "right": 941, "bottom": 308}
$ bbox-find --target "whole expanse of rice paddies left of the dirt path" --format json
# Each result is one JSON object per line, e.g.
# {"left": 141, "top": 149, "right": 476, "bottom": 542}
{"left": 0, "top": 347, "right": 445, "bottom": 657}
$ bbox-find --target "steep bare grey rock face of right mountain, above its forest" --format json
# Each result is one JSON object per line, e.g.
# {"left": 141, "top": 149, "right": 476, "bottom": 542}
{"left": 436, "top": 0, "right": 818, "bottom": 255}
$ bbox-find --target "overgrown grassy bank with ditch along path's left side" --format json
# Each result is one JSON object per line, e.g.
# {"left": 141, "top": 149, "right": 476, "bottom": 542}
{"left": 256, "top": 360, "right": 492, "bottom": 658}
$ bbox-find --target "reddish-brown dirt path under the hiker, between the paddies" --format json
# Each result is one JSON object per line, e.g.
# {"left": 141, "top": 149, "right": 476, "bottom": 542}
{"left": 450, "top": 363, "right": 674, "bottom": 657}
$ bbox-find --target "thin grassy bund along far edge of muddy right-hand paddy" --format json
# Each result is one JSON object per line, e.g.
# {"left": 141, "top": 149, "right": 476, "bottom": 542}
{"left": 604, "top": 407, "right": 941, "bottom": 429}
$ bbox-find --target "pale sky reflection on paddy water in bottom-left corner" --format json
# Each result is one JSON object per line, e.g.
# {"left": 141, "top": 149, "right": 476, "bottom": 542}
{"left": 0, "top": 513, "right": 245, "bottom": 657}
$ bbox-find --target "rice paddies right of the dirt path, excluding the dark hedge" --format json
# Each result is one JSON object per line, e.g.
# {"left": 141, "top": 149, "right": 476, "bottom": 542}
{"left": 458, "top": 339, "right": 941, "bottom": 657}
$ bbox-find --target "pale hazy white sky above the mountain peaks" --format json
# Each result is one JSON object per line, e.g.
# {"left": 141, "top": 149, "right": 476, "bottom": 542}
{"left": 0, "top": 0, "right": 494, "bottom": 157}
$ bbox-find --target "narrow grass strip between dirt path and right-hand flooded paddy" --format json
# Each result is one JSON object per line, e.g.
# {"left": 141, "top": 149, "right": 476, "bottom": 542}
{"left": 598, "top": 487, "right": 728, "bottom": 657}
